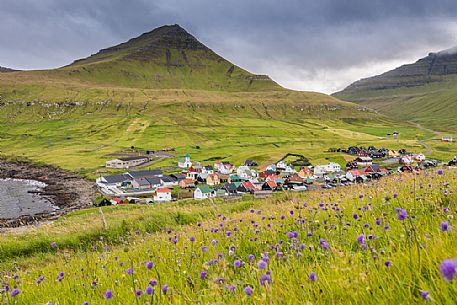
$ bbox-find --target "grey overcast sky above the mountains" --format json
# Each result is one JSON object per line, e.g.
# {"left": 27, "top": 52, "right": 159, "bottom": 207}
{"left": 0, "top": 0, "right": 457, "bottom": 93}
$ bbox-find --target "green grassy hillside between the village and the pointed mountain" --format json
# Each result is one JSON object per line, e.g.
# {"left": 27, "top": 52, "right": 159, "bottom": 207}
{"left": 0, "top": 96, "right": 455, "bottom": 178}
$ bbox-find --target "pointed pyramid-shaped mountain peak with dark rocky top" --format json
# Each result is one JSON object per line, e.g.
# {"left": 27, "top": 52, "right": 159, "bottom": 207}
{"left": 49, "top": 25, "right": 282, "bottom": 91}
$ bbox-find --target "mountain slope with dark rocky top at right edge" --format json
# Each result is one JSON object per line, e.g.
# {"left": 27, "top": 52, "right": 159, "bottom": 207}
{"left": 333, "top": 48, "right": 457, "bottom": 131}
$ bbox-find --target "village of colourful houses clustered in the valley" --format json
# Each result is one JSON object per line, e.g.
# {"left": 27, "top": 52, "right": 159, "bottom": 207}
{"left": 96, "top": 146, "right": 457, "bottom": 205}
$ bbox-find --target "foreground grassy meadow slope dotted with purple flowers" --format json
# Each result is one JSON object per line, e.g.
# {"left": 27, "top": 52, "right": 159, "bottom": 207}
{"left": 0, "top": 168, "right": 457, "bottom": 304}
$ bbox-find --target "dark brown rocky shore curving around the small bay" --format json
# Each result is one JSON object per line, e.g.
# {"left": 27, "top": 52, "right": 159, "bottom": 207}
{"left": 0, "top": 160, "right": 97, "bottom": 228}
